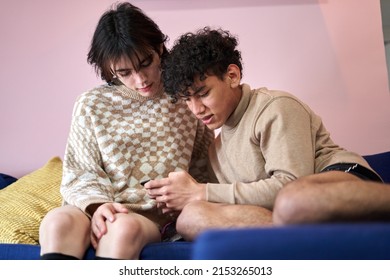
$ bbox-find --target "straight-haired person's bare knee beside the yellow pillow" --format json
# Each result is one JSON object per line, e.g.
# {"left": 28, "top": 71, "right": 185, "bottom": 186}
{"left": 39, "top": 205, "right": 90, "bottom": 259}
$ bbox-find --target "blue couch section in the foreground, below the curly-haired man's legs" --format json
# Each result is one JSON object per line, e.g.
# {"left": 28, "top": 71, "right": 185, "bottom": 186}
{"left": 193, "top": 223, "right": 390, "bottom": 260}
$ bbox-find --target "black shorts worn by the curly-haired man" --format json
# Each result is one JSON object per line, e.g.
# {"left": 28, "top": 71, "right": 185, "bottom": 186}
{"left": 321, "top": 163, "right": 383, "bottom": 183}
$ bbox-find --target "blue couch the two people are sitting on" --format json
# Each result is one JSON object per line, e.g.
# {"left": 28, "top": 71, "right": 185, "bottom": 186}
{"left": 0, "top": 152, "right": 390, "bottom": 260}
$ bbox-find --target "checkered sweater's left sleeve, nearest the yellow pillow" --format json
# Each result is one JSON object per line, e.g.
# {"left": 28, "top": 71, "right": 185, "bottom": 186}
{"left": 60, "top": 98, "right": 114, "bottom": 212}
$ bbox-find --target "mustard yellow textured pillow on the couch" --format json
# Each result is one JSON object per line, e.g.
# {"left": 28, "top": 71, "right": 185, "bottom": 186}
{"left": 0, "top": 157, "right": 62, "bottom": 244}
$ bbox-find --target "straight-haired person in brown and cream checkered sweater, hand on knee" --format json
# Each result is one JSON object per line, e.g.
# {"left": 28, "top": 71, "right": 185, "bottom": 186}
{"left": 40, "top": 3, "right": 214, "bottom": 259}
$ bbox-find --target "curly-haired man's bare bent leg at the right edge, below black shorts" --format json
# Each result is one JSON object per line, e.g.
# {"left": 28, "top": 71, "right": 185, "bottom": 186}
{"left": 273, "top": 171, "right": 390, "bottom": 224}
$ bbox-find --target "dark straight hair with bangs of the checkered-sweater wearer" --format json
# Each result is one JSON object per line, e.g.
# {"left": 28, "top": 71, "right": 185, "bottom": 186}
{"left": 88, "top": 2, "right": 168, "bottom": 82}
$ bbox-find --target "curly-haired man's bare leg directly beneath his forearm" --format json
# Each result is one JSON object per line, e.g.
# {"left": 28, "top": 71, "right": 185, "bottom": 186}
{"left": 176, "top": 201, "right": 272, "bottom": 241}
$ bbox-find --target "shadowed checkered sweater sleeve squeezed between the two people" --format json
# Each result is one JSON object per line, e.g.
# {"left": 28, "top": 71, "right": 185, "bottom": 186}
{"left": 189, "top": 121, "right": 215, "bottom": 183}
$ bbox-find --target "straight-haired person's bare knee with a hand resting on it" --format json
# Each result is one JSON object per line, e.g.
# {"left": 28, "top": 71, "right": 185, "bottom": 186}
{"left": 96, "top": 213, "right": 161, "bottom": 259}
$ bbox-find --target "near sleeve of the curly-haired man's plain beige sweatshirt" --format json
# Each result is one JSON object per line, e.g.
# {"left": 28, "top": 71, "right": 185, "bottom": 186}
{"left": 207, "top": 97, "right": 314, "bottom": 210}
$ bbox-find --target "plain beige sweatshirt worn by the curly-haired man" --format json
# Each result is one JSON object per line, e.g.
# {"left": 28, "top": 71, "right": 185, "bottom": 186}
{"left": 207, "top": 84, "right": 372, "bottom": 209}
